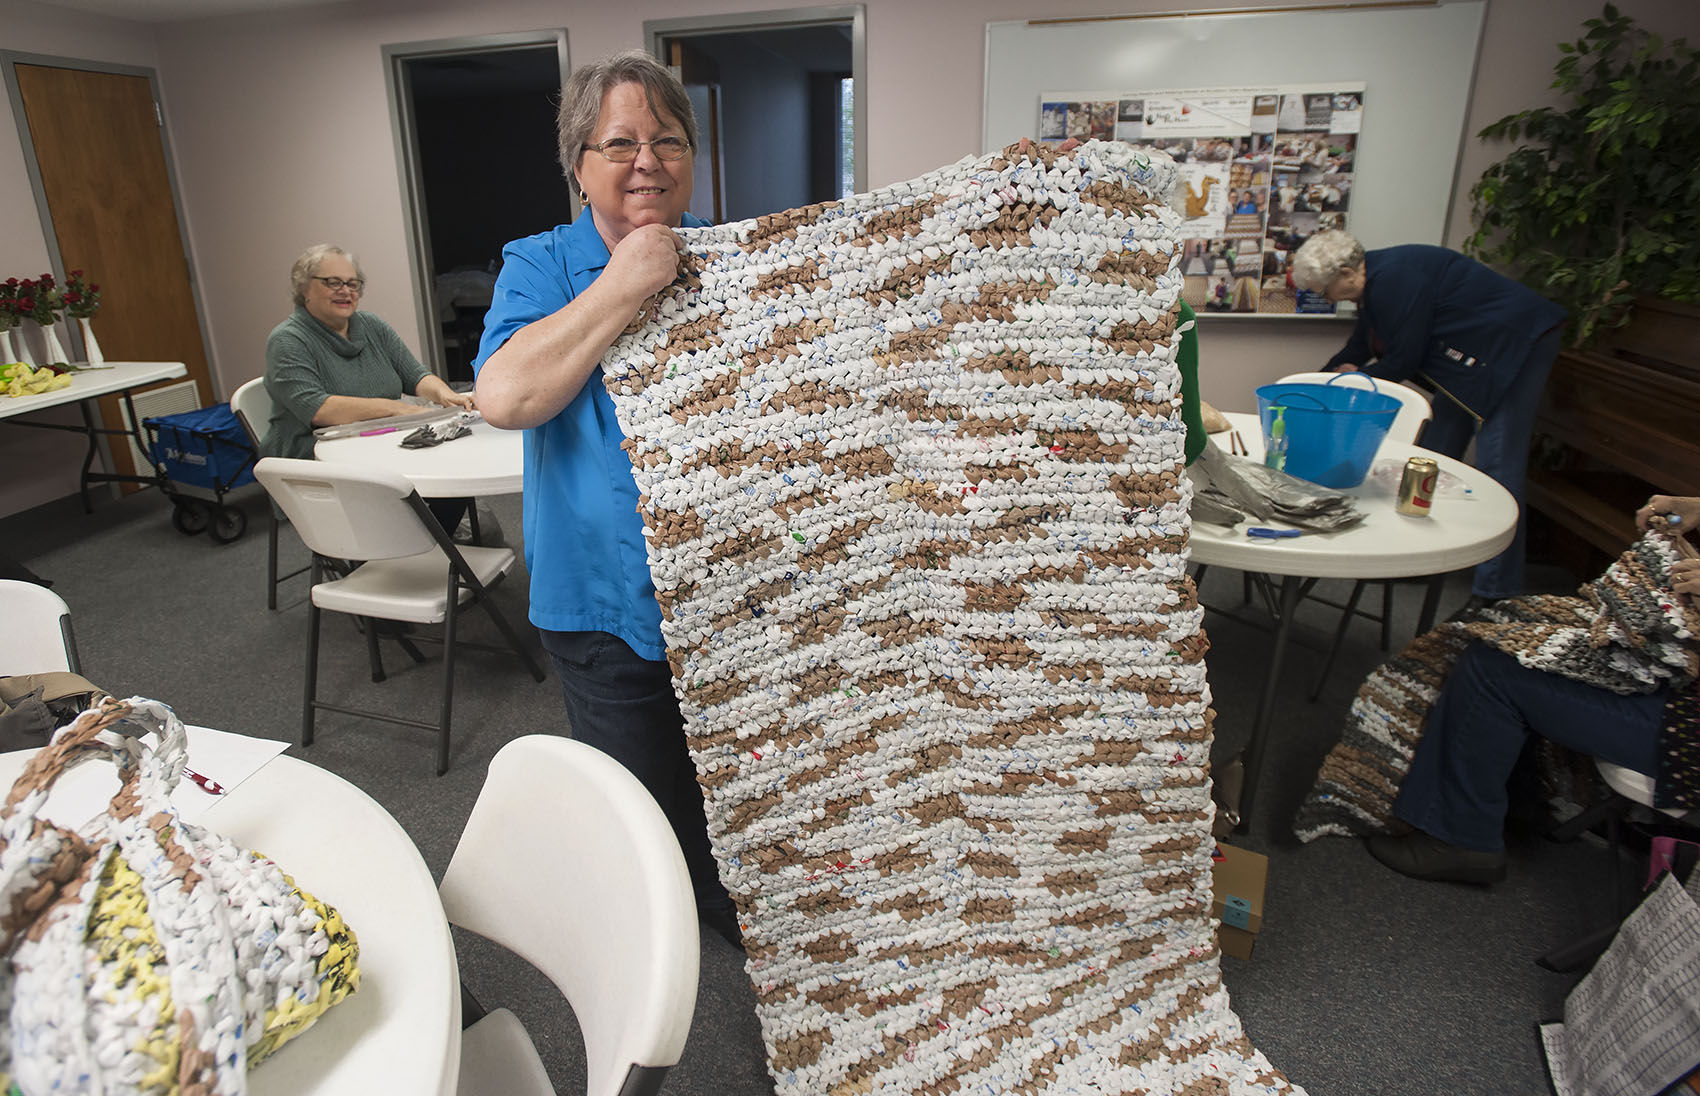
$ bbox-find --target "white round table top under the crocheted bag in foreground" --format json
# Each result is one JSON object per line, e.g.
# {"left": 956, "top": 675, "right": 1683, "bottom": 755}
{"left": 0, "top": 751, "right": 461, "bottom": 1096}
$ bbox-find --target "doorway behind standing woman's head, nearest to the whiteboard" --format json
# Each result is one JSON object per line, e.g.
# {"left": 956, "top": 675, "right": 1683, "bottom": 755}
{"left": 644, "top": 5, "right": 867, "bottom": 223}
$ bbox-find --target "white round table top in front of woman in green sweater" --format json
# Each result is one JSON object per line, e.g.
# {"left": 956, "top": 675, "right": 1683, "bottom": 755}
{"left": 313, "top": 421, "right": 525, "bottom": 498}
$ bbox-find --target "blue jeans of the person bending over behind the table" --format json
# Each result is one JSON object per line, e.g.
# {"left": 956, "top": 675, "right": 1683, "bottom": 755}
{"left": 1421, "top": 328, "right": 1561, "bottom": 598}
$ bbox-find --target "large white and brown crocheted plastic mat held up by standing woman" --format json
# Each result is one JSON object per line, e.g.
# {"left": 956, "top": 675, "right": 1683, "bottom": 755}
{"left": 604, "top": 143, "right": 1299, "bottom": 1096}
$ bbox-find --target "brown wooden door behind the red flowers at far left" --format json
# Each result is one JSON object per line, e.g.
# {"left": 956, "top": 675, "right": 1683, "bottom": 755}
{"left": 15, "top": 65, "right": 214, "bottom": 489}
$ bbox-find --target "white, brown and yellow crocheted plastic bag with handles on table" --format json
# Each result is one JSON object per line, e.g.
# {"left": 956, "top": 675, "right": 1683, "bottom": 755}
{"left": 0, "top": 697, "right": 359, "bottom": 1096}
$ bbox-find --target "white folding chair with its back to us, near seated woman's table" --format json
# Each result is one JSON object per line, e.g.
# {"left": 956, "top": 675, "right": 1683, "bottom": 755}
{"left": 253, "top": 457, "right": 544, "bottom": 775}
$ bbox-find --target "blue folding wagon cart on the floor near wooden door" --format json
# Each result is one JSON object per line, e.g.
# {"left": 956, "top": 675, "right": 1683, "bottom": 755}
{"left": 141, "top": 403, "right": 260, "bottom": 544}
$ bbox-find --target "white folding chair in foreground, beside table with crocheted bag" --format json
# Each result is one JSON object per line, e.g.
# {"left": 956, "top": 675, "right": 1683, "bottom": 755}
{"left": 439, "top": 734, "right": 700, "bottom": 1096}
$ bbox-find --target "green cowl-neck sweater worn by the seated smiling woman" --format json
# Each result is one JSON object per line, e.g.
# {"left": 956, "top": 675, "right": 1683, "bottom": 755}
{"left": 260, "top": 308, "right": 427, "bottom": 460}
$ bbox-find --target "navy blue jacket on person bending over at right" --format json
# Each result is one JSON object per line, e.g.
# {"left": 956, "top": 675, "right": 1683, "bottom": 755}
{"left": 1328, "top": 243, "right": 1564, "bottom": 418}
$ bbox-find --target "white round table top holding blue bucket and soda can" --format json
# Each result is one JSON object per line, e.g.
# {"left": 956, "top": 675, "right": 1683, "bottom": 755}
{"left": 1192, "top": 413, "right": 1516, "bottom": 578}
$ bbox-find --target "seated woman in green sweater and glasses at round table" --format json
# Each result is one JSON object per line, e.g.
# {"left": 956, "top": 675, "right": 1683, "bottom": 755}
{"left": 260, "top": 243, "right": 476, "bottom": 532}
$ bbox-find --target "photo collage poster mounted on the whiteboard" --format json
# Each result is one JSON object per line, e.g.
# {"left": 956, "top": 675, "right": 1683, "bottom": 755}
{"left": 1039, "top": 85, "right": 1363, "bottom": 316}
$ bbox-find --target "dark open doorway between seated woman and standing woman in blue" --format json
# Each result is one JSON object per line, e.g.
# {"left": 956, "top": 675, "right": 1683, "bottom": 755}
{"left": 384, "top": 31, "right": 576, "bottom": 384}
